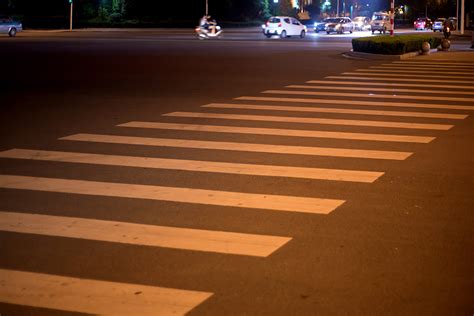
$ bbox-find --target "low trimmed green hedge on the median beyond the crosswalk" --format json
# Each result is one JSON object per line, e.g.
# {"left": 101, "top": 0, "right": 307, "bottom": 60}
{"left": 352, "top": 35, "right": 441, "bottom": 55}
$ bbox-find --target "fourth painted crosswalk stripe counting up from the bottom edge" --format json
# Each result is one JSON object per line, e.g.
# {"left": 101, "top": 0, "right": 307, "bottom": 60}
{"left": 0, "top": 149, "right": 383, "bottom": 183}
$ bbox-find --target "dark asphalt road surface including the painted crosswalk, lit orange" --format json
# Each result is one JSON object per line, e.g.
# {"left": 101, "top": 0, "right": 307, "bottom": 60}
{"left": 0, "top": 30, "right": 474, "bottom": 316}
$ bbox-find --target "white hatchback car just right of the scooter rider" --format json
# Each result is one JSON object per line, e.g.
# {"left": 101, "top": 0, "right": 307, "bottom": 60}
{"left": 262, "top": 16, "right": 306, "bottom": 38}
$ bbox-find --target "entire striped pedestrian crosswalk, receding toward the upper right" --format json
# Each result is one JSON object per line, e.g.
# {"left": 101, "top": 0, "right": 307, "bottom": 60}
{"left": 0, "top": 61, "right": 474, "bottom": 315}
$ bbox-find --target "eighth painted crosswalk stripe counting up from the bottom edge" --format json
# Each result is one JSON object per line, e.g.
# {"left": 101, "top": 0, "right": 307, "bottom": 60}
{"left": 201, "top": 99, "right": 466, "bottom": 120}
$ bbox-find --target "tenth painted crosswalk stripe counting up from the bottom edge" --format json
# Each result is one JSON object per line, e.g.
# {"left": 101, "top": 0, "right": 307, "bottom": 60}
{"left": 261, "top": 90, "right": 474, "bottom": 104}
